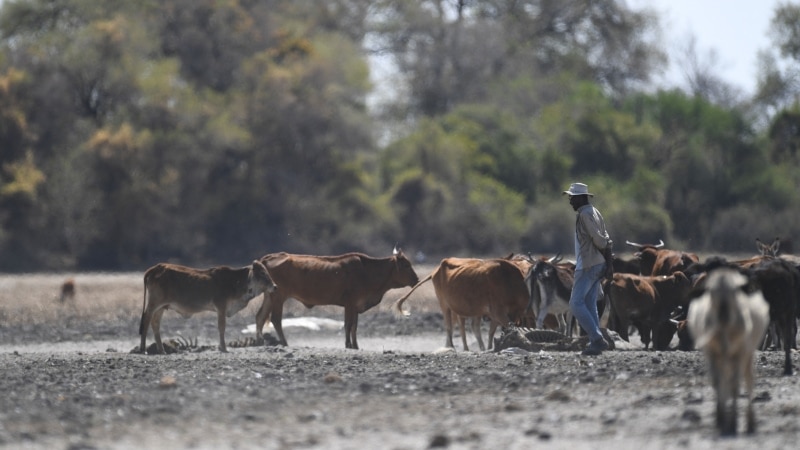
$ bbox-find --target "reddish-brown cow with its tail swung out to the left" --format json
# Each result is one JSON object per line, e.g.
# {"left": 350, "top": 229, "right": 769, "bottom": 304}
{"left": 392, "top": 258, "right": 530, "bottom": 350}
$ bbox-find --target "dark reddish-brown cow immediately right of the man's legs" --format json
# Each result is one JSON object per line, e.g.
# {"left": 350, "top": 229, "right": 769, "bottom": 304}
{"left": 606, "top": 272, "right": 692, "bottom": 350}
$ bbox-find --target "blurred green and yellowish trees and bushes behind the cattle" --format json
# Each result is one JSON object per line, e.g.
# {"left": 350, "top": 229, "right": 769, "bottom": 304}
{"left": 0, "top": 0, "right": 800, "bottom": 271}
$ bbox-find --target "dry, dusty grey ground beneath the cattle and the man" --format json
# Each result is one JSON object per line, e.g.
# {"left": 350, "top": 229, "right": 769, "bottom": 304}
{"left": 0, "top": 270, "right": 800, "bottom": 449}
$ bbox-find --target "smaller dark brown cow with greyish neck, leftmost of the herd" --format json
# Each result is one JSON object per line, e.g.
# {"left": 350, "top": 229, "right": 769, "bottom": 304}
{"left": 139, "top": 261, "right": 275, "bottom": 354}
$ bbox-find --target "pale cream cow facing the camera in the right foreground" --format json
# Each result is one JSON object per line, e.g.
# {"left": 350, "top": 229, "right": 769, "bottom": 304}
{"left": 687, "top": 268, "right": 769, "bottom": 435}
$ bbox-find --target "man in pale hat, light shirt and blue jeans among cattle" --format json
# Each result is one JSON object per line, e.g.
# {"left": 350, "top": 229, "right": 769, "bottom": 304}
{"left": 564, "top": 183, "right": 614, "bottom": 355}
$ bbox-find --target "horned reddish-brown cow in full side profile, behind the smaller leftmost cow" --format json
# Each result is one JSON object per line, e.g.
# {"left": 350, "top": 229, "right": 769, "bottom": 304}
{"left": 256, "top": 249, "right": 419, "bottom": 349}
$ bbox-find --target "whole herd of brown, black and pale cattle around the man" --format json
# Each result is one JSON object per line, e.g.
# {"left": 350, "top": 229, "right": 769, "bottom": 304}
{"left": 139, "top": 239, "right": 800, "bottom": 434}
